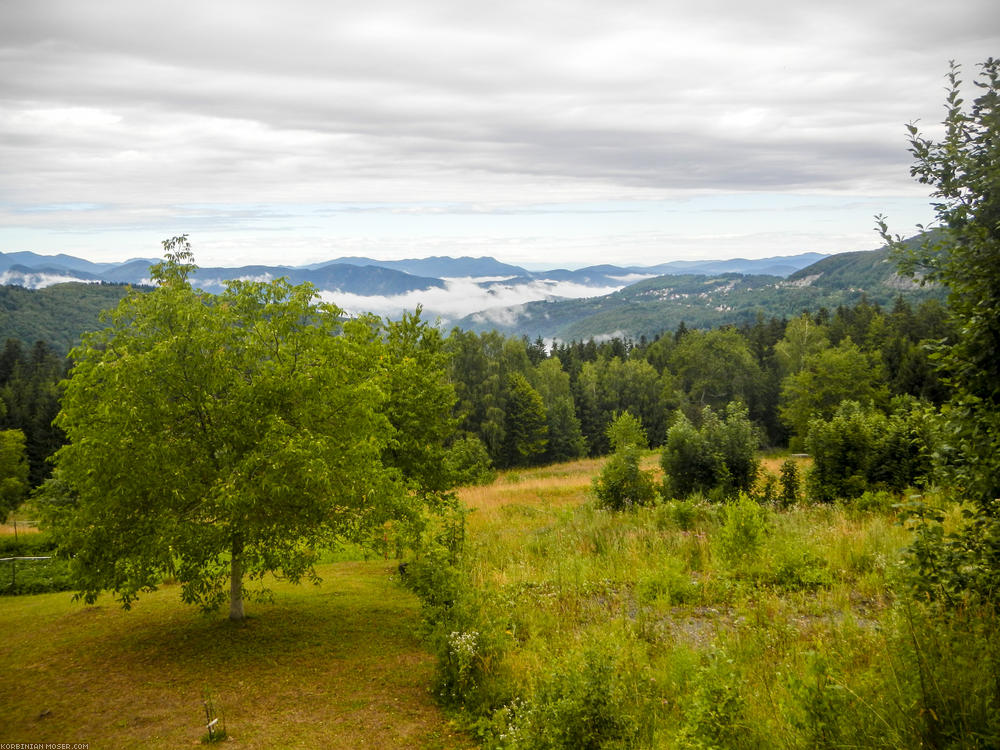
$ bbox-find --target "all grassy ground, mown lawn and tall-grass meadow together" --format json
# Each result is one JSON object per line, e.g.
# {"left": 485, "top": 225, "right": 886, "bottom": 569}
{"left": 0, "top": 454, "right": 1000, "bottom": 750}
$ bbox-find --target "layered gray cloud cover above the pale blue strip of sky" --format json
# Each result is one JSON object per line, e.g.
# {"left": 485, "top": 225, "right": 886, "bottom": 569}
{"left": 0, "top": 0, "right": 1000, "bottom": 264}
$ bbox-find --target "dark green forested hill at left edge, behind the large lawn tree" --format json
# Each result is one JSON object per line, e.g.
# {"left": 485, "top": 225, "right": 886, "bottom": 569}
{"left": 0, "top": 282, "right": 136, "bottom": 354}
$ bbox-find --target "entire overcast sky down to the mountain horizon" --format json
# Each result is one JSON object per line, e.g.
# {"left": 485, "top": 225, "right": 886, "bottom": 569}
{"left": 0, "top": 0, "right": 1000, "bottom": 267}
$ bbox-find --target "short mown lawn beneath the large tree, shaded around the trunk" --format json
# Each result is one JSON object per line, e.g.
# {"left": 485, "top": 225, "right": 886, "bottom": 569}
{"left": 0, "top": 561, "right": 469, "bottom": 750}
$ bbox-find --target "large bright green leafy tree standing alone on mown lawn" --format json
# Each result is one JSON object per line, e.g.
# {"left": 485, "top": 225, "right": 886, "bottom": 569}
{"left": 50, "top": 237, "right": 438, "bottom": 620}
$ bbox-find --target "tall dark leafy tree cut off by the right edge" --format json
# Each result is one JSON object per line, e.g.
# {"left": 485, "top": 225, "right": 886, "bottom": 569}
{"left": 878, "top": 58, "right": 1000, "bottom": 601}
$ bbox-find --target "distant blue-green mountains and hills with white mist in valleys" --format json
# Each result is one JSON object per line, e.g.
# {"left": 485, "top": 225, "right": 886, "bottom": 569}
{"left": 0, "top": 248, "right": 943, "bottom": 349}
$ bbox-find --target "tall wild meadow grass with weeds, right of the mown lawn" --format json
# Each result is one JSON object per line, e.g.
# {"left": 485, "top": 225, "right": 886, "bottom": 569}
{"left": 411, "top": 462, "right": 1000, "bottom": 748}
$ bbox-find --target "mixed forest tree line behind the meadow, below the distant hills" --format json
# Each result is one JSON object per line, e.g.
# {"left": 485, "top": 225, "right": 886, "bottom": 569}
{"left": 445, "top": 298, "right": 954, "bottom": 468}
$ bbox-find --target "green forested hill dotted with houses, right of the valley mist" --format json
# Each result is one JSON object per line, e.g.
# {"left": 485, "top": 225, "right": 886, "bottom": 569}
{"left": 459, "top": 248, "right": 945, "bottom": 341}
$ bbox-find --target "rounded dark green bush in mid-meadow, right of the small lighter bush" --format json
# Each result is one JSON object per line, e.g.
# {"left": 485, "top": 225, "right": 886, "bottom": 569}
{"left": 660, "top": 401, "right": 760, "bottom": 498}
